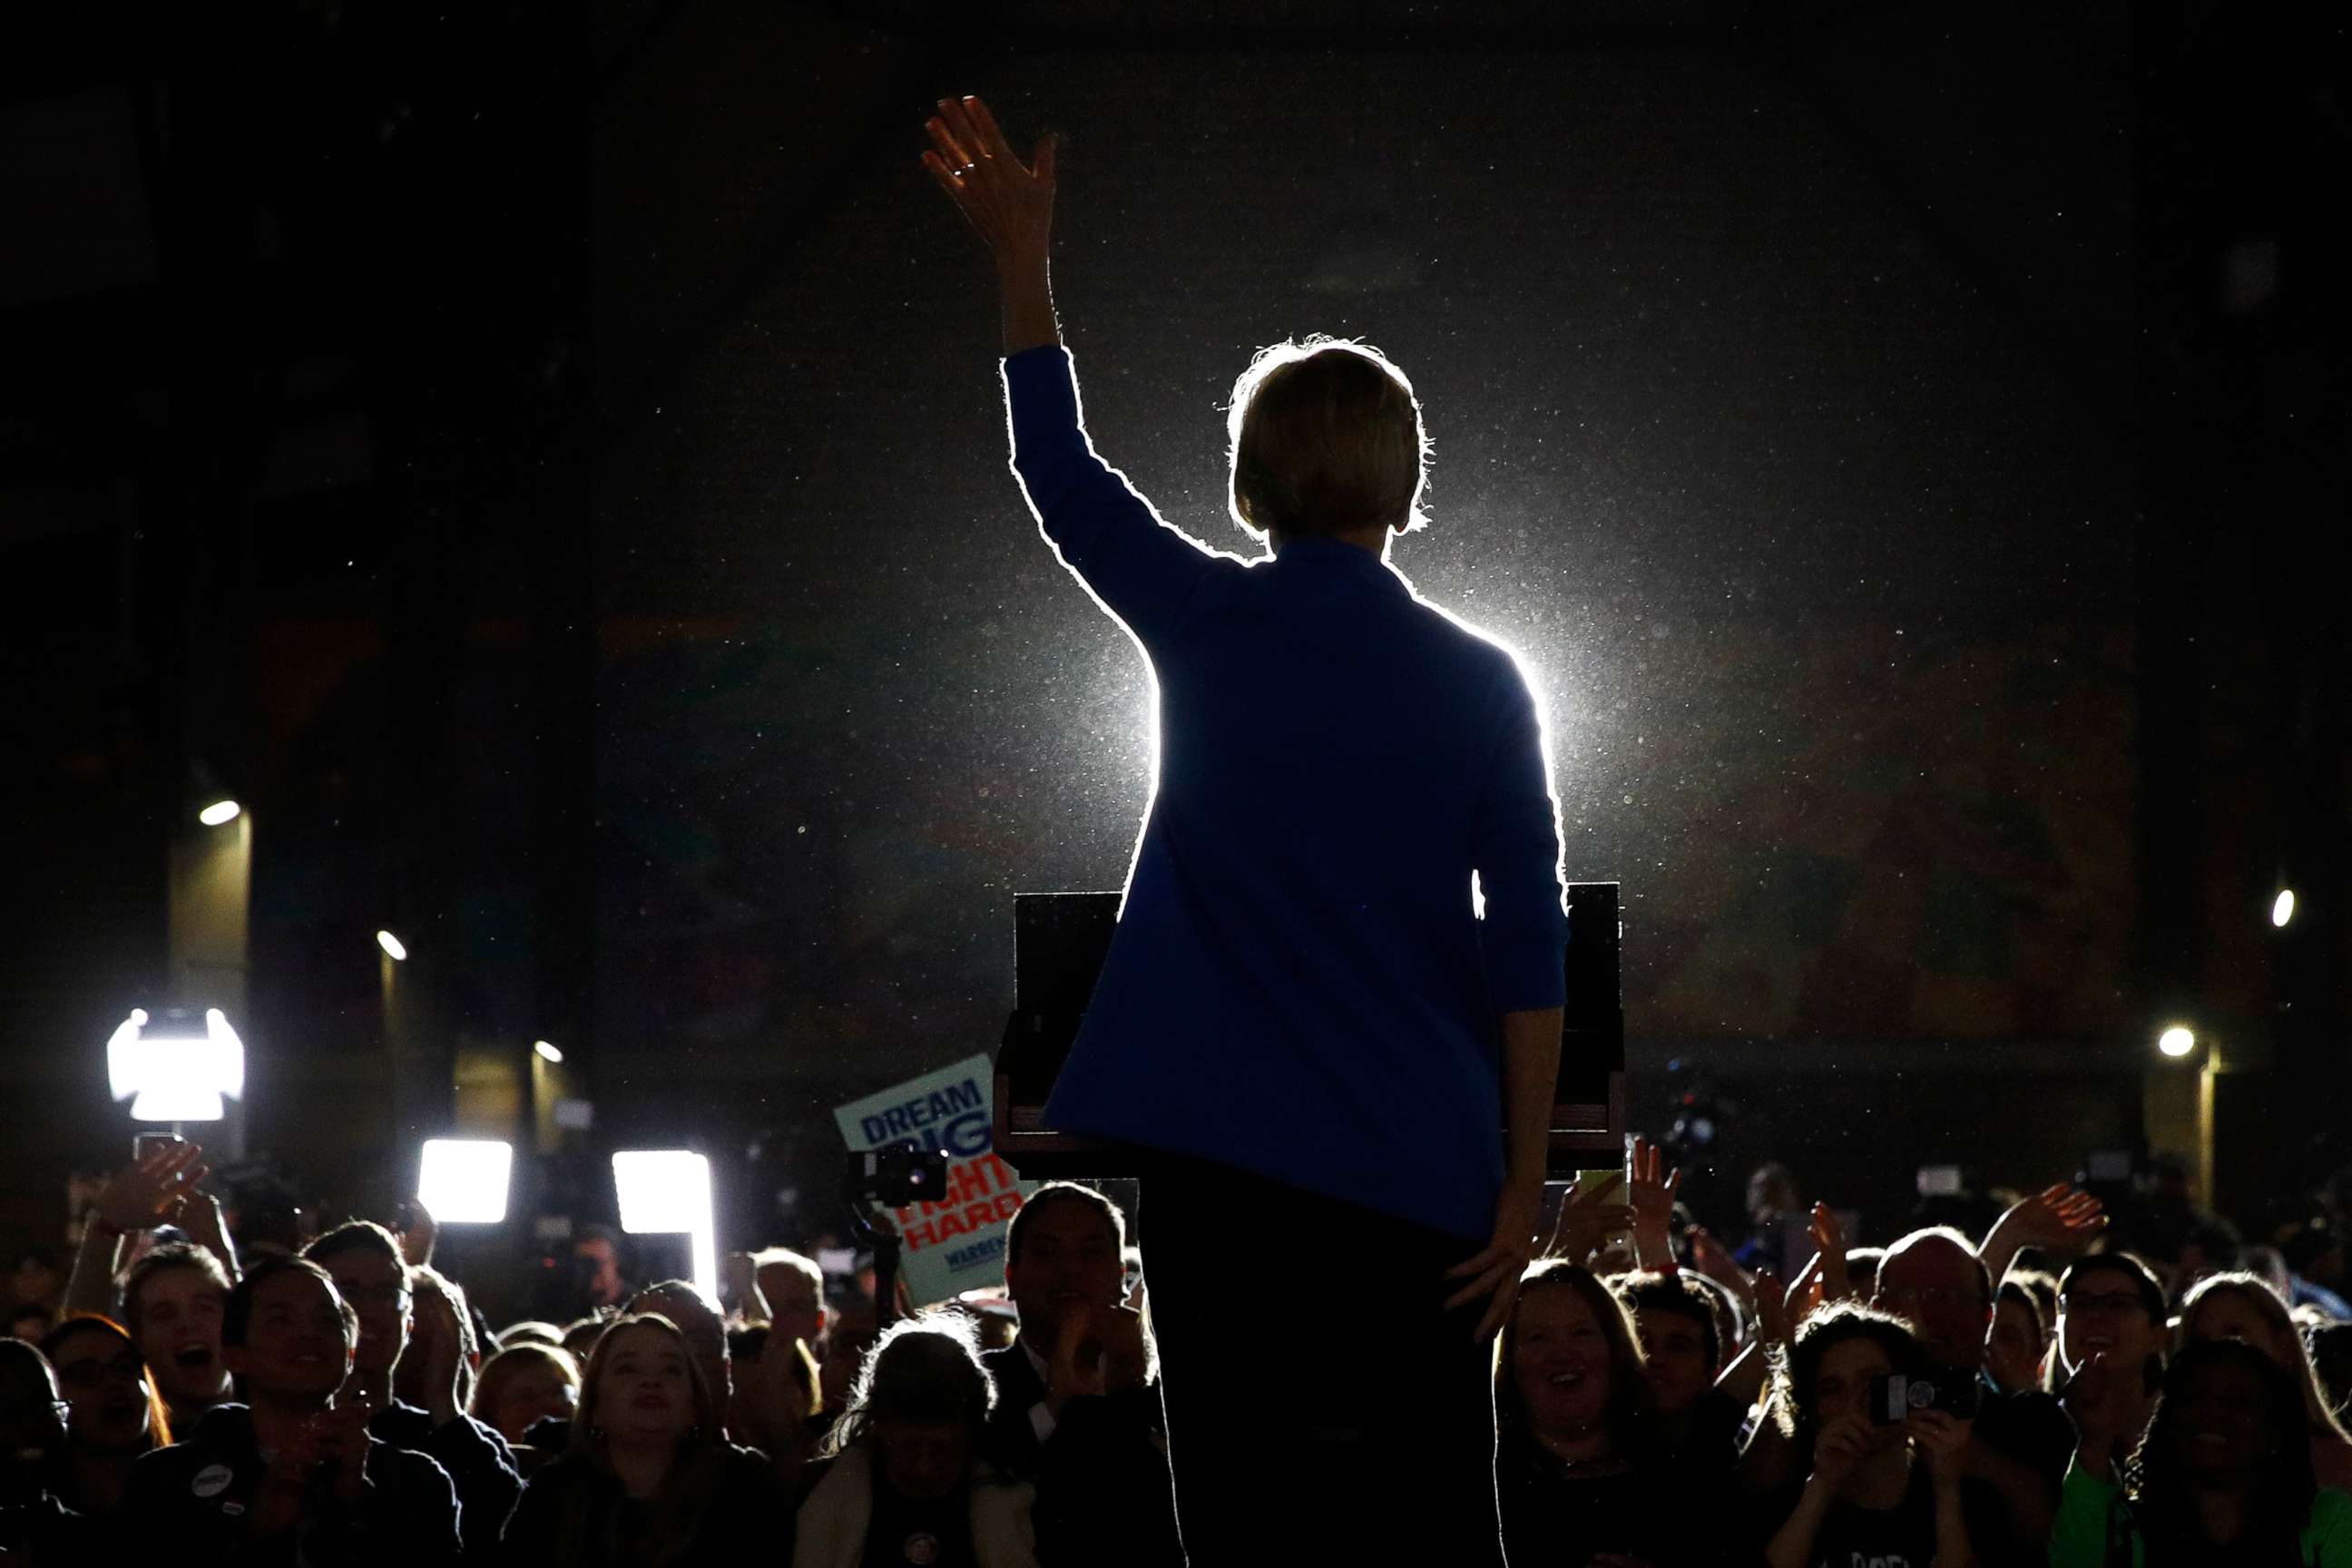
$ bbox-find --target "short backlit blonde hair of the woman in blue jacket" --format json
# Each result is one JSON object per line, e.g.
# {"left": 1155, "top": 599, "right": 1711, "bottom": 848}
{"left": 1225, "top": 331, "right": 1433, "bottom": 538}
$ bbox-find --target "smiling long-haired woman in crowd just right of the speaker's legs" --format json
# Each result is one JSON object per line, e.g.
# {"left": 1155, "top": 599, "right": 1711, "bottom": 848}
{"left": 1494, "top": 1258, "right": 1724, "bottom": 1568}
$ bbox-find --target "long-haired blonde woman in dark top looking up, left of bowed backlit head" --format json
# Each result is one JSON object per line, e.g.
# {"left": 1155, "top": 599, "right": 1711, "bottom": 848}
{"left": 504, "top": 1312, "right": 793, "bottom": 1568}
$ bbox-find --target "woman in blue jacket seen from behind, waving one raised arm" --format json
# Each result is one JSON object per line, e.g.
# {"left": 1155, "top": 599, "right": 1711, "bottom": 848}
{"left": 922, "top": 99, "right": 1566, "bottom": 1563}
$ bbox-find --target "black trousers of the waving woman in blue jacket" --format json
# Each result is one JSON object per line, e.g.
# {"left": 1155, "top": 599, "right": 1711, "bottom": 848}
{"left": 1139, "top": 1154, "right": 1503, "bottom": 1568}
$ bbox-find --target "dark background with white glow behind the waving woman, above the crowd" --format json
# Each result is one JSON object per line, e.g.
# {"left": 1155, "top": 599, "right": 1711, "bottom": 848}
{"left": 0, "top": 0, "right": 2352, "bottom": 1316}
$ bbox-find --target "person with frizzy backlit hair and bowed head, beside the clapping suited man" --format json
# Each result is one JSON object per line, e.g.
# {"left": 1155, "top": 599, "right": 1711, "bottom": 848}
{"left": 793, "top": 1312, "right": 1030, "bottom": 1568}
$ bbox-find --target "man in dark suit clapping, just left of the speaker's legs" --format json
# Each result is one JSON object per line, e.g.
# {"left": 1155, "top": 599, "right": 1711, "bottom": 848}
{"left": 981, "top": 1182, "right": 1183, "bottom": 1565}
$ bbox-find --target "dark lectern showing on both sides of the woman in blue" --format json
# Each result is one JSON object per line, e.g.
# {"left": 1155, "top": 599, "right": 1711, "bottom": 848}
{"left": 995, "top": 882, "right": 1625, "bottom": 1182}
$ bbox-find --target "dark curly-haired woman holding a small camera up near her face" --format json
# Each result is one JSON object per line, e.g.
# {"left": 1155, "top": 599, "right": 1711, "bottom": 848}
{"left": 1764, "top": 1305, "right": 1999, "bottom": 1568}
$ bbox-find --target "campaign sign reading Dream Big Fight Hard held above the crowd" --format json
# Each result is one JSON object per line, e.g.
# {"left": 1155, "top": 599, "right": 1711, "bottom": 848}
{"left": 833, "top": 1055, "right": 1037, "bottom": 1307}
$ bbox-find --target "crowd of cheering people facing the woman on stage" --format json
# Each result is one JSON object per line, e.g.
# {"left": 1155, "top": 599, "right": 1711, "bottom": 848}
{"left": 0, "top": 1145, "right": 2352, "bottom": 1568}
